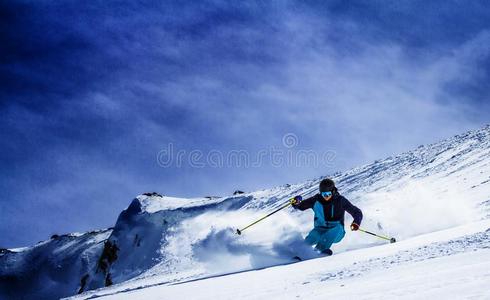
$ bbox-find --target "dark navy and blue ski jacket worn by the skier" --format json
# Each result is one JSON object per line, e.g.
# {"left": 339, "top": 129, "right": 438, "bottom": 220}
{"left": 296, "top": 192, "right": 362, "bottom": 227}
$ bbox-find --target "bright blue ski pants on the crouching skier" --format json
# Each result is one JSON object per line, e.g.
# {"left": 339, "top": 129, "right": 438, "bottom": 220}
{"left": 305, "top": 222, "right": 345, "bottom": 251}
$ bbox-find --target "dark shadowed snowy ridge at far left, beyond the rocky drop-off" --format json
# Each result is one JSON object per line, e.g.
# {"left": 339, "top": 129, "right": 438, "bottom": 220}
{"left": 0, "top": 229, "right": 112, "bottom": 299}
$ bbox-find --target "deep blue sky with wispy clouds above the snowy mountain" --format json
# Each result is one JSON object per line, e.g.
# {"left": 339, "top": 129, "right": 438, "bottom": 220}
{"left": 0, "top": 1, "right": 490, "bottom": 247}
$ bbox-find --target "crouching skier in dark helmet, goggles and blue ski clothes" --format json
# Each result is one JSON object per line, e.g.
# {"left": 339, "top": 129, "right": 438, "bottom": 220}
{"left": 291, "top": 178, "right": 362, "bottom": 255}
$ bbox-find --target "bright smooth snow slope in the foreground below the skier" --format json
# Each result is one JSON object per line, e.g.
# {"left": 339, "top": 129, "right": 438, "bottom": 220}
{"left": 71, "top": 220, "right": 490, "bottom": 300}
